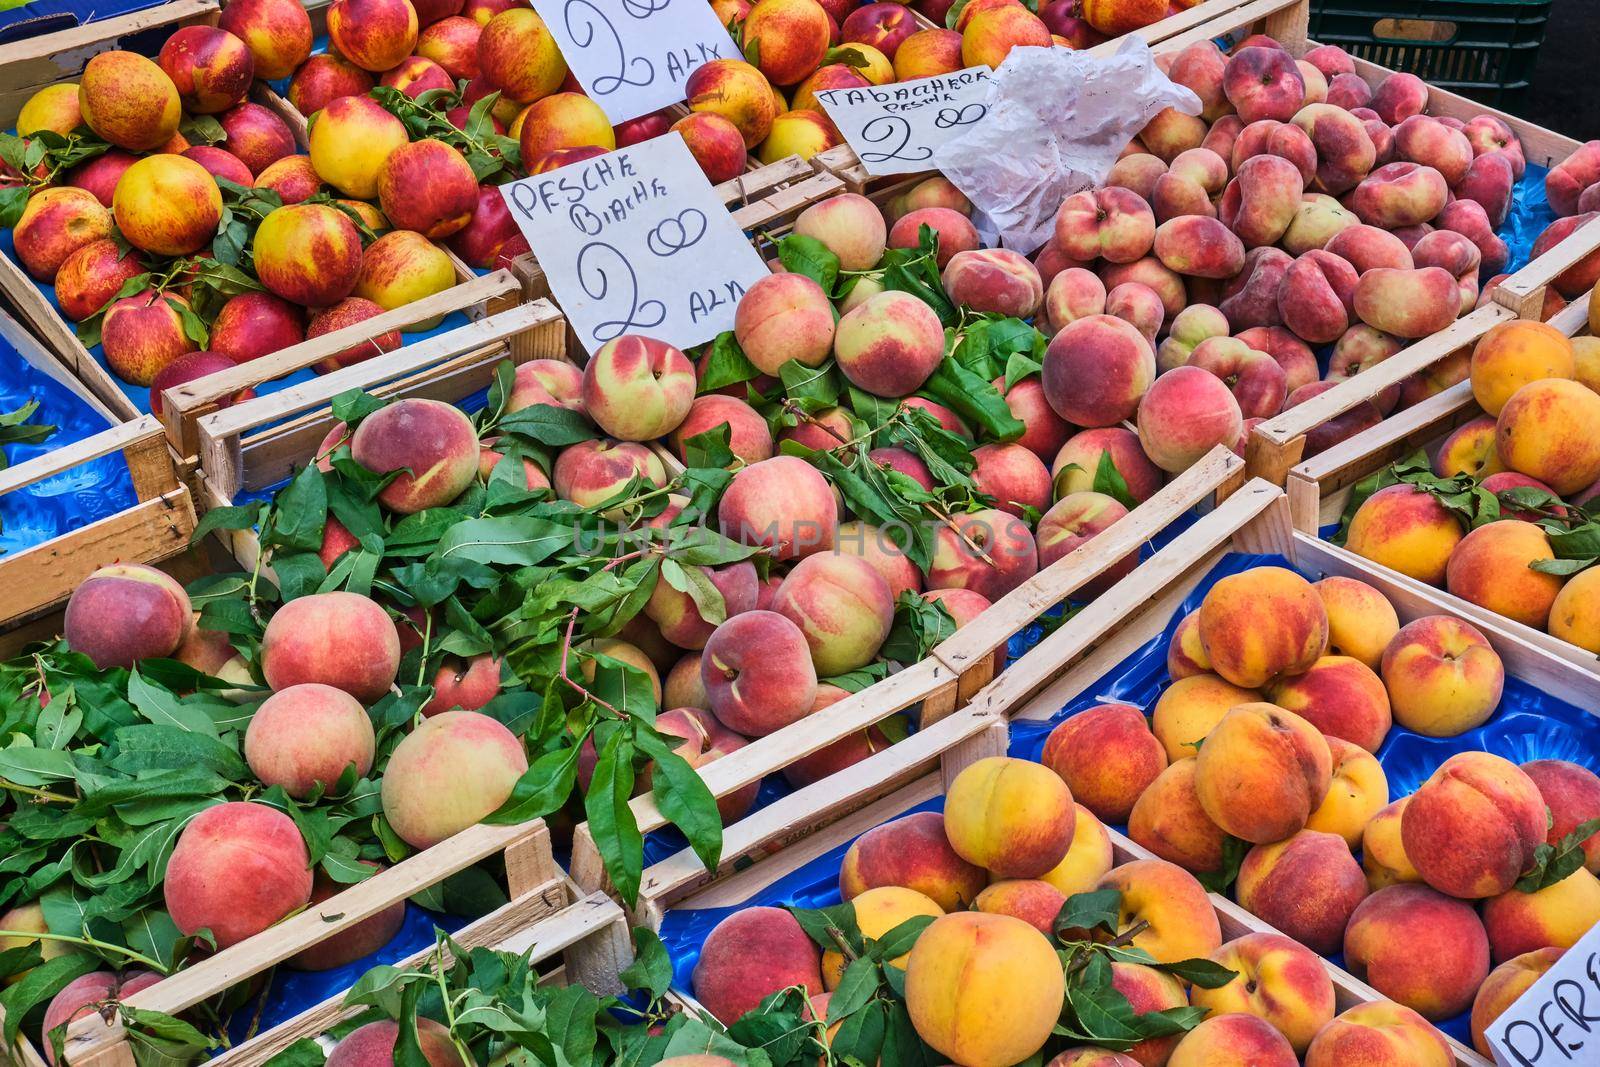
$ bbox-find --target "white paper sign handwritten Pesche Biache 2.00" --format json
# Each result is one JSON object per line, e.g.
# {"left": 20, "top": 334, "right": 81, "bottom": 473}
{"left": 501, "top": 133, "right": 770, "bottom": 354}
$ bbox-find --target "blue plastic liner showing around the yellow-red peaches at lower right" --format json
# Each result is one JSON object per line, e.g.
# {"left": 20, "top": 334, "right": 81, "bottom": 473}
{"left": 661, "top": 553, "right": 1600, "bottom": 1041}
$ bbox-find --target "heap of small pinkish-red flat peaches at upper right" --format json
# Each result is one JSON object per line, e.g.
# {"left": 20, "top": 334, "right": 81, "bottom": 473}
{"left": 926, "top": 37, "right": 1592, "bottom": 486}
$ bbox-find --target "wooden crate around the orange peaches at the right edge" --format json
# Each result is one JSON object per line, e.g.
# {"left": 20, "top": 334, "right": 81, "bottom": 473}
{"left": 1286, "top": 287, "right": 1597, "bottom": 671}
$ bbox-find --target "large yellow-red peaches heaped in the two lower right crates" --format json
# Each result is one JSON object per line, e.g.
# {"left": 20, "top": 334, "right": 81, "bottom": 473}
{"left": 693, "top": 566, "right": 1600, "bottom": 1067}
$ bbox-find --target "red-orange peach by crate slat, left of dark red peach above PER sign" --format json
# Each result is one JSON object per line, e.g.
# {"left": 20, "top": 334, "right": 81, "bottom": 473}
{"left": 1235, "top": 831, "right": 1366, "bottom": 955}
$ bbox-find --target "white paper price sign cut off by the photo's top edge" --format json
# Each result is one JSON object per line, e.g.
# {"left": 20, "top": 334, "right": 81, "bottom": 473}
{"left": 533, "top": 0, "right": 742, "bottom": 123}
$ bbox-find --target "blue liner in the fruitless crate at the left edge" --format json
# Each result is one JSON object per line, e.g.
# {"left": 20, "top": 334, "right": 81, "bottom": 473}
{"left": 0, "top": 321, "right": 138, "bottom": 555}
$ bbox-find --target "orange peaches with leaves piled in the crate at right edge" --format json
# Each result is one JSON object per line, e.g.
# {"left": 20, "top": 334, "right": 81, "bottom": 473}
{"left": 1346, "top": 313, "right": 1600, "bottom": 653}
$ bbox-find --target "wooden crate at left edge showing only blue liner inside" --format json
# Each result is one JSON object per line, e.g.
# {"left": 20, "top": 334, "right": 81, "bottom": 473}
{"left": 0, "top": 414, "right": 195, "bottom": 639}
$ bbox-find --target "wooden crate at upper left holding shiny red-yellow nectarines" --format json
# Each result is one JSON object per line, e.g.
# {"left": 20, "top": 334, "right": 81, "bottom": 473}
{"left": 0, "top": 0, "right": 522, "bottom": 438}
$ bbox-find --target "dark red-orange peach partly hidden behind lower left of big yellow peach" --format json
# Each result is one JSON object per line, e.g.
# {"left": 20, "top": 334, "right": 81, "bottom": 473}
{"left": 838, "top": 811, "right": 987, "bottom": 912}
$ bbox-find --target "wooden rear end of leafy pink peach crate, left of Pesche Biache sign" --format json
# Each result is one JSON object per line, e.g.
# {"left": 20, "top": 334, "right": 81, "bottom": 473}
{"left": 196, "top": 301, "right": 566, "bottom": 509}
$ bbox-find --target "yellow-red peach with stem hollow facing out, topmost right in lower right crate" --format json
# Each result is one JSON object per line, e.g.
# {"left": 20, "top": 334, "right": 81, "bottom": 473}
{"left": 1382, "top": 614, "right": 1506, "bottom": 737}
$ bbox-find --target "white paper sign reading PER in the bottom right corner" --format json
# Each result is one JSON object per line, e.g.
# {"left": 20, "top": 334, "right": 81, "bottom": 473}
{"left": 1485, "top": 926, "right": 1600, "bottom": 1067}
